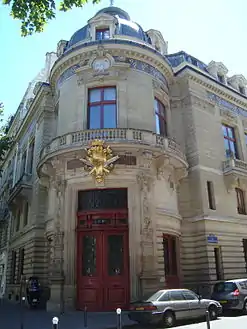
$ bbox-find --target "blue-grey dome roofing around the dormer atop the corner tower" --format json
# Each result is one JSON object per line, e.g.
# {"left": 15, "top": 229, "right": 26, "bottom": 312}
{"left": 67, "top": 6, "right": 150, "bottom": 49}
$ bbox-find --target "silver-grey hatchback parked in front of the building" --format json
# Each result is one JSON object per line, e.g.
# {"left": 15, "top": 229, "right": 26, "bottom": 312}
{"left": 129, "top": 289, "right": 222, "bottom": 328}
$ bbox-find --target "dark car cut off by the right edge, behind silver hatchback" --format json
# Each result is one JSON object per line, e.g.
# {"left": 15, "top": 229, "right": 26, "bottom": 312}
{"left": 211, "top": 279, "right": 247, "bottom": 314}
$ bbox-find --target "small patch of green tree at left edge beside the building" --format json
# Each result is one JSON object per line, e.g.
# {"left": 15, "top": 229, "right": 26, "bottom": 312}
{"left": 0, "top": 103, "right": 14, "bottom": 167}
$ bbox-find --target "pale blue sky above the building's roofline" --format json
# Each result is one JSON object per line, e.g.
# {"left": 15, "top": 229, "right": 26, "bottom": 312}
{"left": 0, "top": 0, "right": 247, "bottom": 120}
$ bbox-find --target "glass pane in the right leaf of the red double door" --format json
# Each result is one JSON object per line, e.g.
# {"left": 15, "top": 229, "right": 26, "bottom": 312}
{"left": 107, "top": 235, "right": 124, "bottom": 276}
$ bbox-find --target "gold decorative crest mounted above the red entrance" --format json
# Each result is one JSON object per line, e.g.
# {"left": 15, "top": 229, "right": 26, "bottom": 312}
{"left": 81, "top": 139, "right": 119, "bottom": 183}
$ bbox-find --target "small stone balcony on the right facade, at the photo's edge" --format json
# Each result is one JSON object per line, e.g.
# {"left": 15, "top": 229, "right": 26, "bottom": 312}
{"left": 222, "top": 158, "right": 247, "bottom": 190}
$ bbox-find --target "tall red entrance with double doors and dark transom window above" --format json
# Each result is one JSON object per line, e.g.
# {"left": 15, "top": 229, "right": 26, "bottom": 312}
{"left": 77, "top": 189, "right": 130, "bottom": 311}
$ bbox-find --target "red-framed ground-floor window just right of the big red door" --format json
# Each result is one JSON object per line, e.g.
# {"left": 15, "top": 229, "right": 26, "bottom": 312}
{"left": 163, "top": 234, "right": 178, "bottom": 276}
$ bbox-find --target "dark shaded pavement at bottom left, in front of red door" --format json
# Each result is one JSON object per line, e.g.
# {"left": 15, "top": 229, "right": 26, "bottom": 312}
{"left": 0, "top": 301, "right": 135, "bottom": 329}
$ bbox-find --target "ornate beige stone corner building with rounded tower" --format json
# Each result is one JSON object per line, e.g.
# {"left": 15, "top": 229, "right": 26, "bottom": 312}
{"left": 0, "top": 7, "right": 247, "bottom": 310}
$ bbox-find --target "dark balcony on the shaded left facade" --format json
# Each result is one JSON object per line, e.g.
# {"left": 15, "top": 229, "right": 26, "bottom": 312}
{"left": 8, "top": 173, "right": 32, "bottom": 204}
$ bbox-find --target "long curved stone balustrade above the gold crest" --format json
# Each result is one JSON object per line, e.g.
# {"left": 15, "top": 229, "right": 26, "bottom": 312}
{"left": 40, "top": 128, "right": 186, "bottom": 161}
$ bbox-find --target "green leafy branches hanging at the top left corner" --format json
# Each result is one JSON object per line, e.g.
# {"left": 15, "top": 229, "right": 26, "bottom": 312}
{"left": 2, "top": 0, "right": 101, "bottom": 36}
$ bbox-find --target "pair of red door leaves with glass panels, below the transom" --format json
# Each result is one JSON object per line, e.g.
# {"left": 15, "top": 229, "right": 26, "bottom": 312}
{"left": 77, "top": 230, "right": 129, "bottom": 311}
